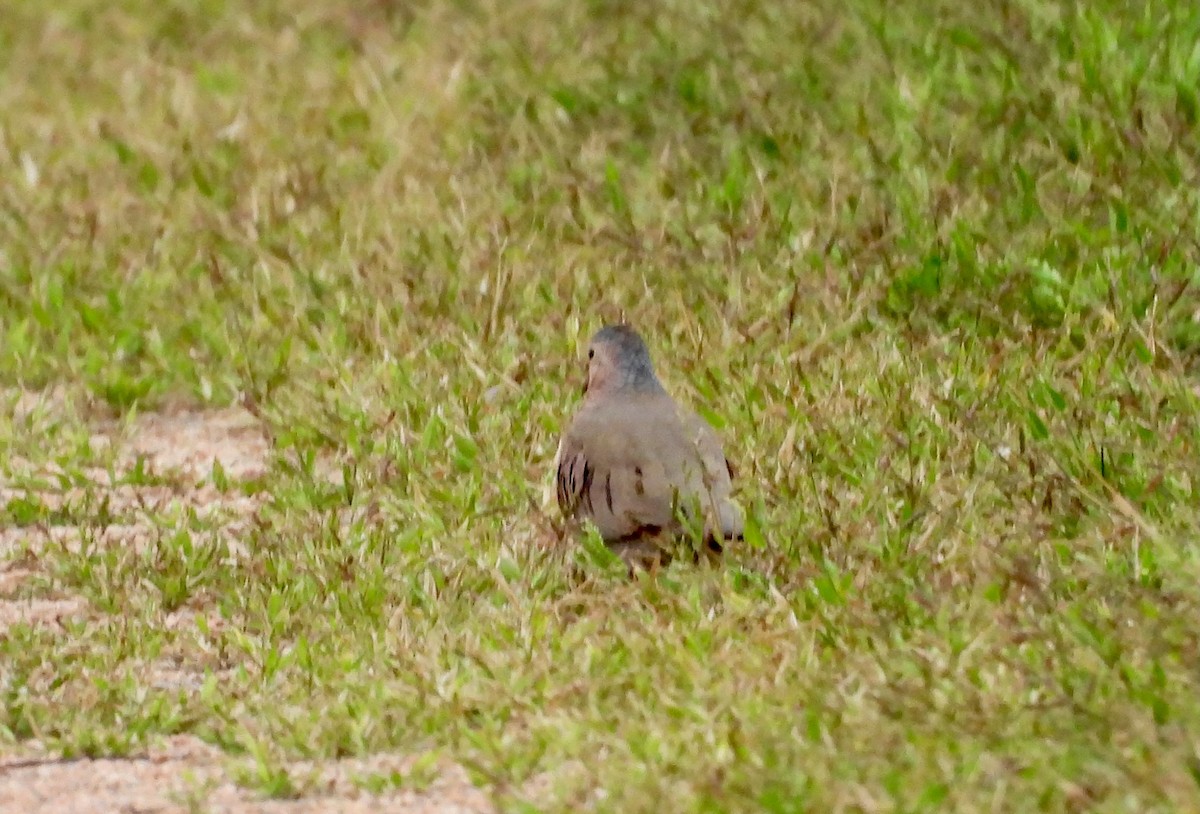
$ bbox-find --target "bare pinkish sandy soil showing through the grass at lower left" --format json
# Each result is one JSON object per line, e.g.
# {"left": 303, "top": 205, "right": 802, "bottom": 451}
{"left": 0, "top": 394, "right": 494, "bottom": 814}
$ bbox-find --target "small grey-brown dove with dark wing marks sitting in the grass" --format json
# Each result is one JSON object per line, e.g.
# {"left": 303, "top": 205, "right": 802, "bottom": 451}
{"left": 554, "top": 325, "right": 742, "bottom": 567}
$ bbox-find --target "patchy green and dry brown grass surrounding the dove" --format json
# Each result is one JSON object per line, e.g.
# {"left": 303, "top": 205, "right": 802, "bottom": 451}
{"left": 0, "top": 0, "right": 1200, "bottom": 812}
